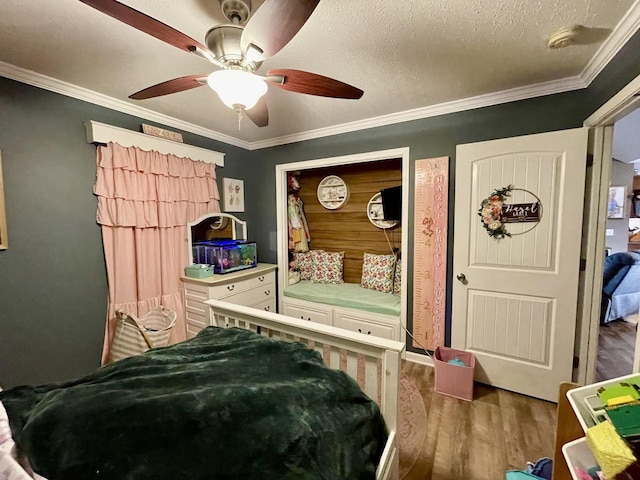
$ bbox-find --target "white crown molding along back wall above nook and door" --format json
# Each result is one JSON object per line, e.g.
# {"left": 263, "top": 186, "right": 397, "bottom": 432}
{"left": 249, "top": 76, "right": 587, "bottom": 150}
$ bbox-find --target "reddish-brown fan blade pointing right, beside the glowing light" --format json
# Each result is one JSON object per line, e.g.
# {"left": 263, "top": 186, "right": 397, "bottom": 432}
{"left": 266, "top": 69, "right": 364, "bottom": 100}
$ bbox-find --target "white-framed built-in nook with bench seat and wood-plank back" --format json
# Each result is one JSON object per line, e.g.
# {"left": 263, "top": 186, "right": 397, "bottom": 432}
{"left": 276, "top": 148, "right": 409, "bottom": 340}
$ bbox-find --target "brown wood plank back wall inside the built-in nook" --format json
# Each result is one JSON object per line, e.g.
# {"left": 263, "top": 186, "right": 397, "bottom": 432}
{"left": 298, "top": 159, "right": 402, "bottom": 283}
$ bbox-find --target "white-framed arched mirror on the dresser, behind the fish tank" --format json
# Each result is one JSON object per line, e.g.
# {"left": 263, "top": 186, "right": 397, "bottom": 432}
{"left": 187, "top": 213, "right": 247, "bottom": 263}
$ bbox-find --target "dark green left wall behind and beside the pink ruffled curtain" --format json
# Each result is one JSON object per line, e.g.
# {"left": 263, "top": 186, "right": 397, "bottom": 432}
{"left": 0, "top": 78, "right": 249, "bottom": 388}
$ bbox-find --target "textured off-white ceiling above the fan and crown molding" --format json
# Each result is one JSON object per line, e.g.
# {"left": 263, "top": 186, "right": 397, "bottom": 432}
{"left": 0, "top": 0, "right": 638, "bottom": 144}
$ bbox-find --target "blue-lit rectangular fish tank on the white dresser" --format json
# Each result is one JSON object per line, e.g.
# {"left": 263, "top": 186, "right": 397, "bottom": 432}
{"left": 192, "top": 239, "right": 258, "bottom": 273}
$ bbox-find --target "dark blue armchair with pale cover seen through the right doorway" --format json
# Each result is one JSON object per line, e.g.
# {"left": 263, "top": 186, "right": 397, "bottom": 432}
{"left": 600, "top": 252, "right": 640, "bottom": 324}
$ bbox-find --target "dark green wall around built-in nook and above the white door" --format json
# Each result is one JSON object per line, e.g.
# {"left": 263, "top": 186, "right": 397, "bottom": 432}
{"left": 245, "top": 29, "right": 640, "bottom": 351}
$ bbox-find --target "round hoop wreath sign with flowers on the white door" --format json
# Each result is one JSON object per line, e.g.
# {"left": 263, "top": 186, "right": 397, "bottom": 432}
{"left": 478, "top": 185, "right": 542, "bottom": 240}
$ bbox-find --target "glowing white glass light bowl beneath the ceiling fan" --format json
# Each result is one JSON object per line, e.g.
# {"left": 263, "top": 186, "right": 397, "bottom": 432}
{"left": 207, "top": 69, "right": 267, "bottom": 110}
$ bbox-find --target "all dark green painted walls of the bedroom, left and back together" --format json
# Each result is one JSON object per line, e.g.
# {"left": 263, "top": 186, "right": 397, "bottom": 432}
{"left": 0, "top": 26, "right": 640, "bottom": 387}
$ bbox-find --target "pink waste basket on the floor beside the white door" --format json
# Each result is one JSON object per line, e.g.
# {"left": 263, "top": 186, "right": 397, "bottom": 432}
{"left": 433, "top": 347, "right": 476, "bottom": 401}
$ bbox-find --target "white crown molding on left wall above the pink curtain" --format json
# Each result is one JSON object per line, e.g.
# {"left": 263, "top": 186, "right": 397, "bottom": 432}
{"left": 0, "top": 62, "right": 250, "bottom": 150}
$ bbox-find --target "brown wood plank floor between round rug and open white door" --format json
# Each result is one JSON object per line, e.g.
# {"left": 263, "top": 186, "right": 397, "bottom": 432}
{"left": 402, "top": 362, "right": 556, "bottom": 480}
